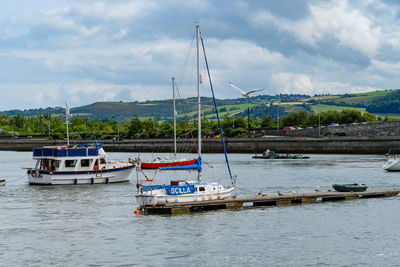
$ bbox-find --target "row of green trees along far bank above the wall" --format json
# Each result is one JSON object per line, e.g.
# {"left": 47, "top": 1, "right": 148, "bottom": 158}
{"left": 0, "top": 110, "right": 390, "bottom": 139}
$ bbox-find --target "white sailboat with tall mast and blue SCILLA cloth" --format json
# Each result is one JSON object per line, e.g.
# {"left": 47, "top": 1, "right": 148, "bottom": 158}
{"left": 136, "top": 25, "right": 236, "bottom": 206}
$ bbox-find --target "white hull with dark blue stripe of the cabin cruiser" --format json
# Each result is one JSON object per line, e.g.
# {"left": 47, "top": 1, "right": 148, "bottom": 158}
{"left": 28, "top": 166, "right": 135, "bottom": 185}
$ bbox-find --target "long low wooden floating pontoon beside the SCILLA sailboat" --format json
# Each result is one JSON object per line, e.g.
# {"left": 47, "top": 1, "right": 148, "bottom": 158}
{"left": 138, "top": 189, "right": 400, "bottom": 214}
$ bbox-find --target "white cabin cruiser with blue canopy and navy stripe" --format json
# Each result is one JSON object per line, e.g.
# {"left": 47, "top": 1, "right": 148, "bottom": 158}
{"left": 27, "top": 143, "right": 136, "bottom": 185}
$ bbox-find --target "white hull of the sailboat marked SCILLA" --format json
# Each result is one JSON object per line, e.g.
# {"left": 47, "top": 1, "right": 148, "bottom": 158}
{"left": 136, "top": 187, "right": 235, "bottom": 206}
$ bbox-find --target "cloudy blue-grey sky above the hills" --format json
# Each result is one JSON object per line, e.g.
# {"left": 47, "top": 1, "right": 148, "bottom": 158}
{"left": 0, "top": 0, "right": 400, "bottom": 110}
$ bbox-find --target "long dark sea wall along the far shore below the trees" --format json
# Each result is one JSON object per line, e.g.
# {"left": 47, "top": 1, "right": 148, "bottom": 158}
{"left": 0, "top": 136, "right": 400, "bottom": 154}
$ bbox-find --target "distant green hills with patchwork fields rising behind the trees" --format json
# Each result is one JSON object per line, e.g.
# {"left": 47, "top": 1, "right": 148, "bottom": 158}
{"left": 0, "top": 89, "right": 400, "bottom": 121}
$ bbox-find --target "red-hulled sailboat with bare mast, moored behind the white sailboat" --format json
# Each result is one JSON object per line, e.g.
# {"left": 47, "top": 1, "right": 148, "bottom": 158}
{"left": 140, "top": 77, "right": 196, "bottom": 169}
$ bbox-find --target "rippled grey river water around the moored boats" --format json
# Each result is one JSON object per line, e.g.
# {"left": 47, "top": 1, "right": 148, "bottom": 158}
{"left": 0, "top": 151, "right": 400, "bottom": 266}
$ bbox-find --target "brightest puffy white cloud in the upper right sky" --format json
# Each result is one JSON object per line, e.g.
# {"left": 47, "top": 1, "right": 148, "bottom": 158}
{"left": 251, "top": 0, "right": 383, "bottom": 57}
